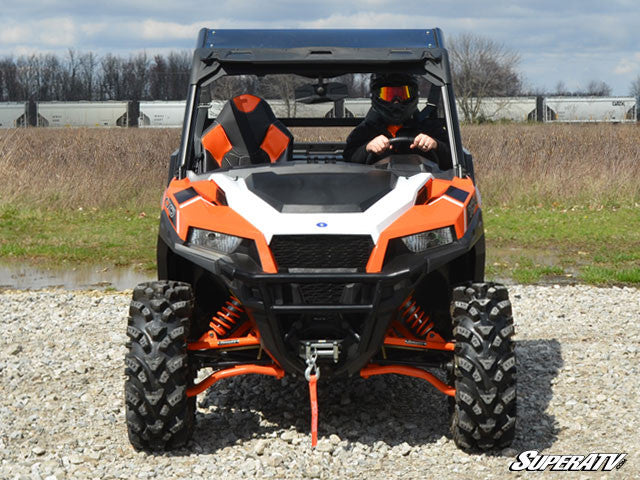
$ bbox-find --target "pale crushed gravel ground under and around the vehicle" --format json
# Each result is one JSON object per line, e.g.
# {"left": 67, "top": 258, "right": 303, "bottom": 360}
{"left": 0, "top": 285, "right": 640, "bottom": 480}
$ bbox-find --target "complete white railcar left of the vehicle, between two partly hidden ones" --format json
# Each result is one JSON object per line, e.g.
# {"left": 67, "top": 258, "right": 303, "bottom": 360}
{"left": 38, "top": 101, "right": 129, "bottom": 127}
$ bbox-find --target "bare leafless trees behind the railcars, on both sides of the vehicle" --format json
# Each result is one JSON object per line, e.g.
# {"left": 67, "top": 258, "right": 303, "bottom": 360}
{"left": 0, "top": 34, "right": 640, "bottom": 121}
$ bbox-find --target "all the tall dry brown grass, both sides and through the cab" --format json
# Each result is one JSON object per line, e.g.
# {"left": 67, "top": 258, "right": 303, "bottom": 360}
{"left": 0, "top": 124, "right": 640, "bottom": 208}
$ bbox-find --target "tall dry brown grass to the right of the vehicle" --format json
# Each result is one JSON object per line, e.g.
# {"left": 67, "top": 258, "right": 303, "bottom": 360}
{"left": 462, "top": 124, "right": 640, "bottom": 207}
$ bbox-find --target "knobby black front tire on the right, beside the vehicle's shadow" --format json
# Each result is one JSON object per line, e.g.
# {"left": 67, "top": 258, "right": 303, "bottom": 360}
{"left": 451, "top": 283, "right": 516, "bottom": 450}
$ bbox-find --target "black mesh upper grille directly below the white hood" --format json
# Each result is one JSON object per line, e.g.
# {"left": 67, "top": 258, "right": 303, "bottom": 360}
{"left": 269, "top": 235, "right": 373, "bottom": 272}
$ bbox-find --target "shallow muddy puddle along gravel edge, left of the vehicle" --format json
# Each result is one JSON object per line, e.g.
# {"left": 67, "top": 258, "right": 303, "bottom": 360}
{"left": 0, "top": 263, "right": 156, "bottom": 290}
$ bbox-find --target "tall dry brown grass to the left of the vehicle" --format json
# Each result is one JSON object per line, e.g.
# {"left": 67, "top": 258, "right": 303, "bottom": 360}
{"left": 0, "top": 128, "right": 180, "bottom": 208}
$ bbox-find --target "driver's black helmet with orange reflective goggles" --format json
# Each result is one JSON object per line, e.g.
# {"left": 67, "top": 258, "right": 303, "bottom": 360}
{"left": 371, "top": 73, "right": 418, "bottom": 125}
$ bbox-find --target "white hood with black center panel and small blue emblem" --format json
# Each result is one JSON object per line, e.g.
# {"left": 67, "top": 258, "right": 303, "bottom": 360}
{"left": 210, "top": 164, "right": 431, "bottom": 243}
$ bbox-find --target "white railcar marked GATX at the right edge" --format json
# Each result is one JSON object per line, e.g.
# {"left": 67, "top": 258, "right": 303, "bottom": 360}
{"left": 543, "top": 97, "right": 638, "bottom": 123}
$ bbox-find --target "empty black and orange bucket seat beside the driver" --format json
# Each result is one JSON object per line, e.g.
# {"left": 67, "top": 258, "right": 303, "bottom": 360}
{"left": 201, "top": 94, "right": 293, "bottom": 168}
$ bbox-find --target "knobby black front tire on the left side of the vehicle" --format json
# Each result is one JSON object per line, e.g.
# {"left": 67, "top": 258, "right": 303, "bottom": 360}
{"left": 125, "top": 280, "right": 195, "bottom": 450}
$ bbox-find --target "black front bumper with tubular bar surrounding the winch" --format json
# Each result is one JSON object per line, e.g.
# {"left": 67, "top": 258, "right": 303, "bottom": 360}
{"left": 160, "top": 212, "right": 483, "bottom": 375}
